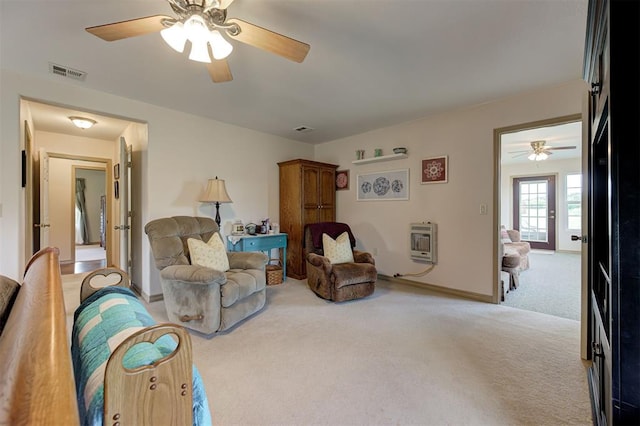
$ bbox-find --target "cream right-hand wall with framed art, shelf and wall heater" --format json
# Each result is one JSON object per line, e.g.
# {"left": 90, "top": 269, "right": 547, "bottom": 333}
{"left": 315, "top": 80, "right": 587, "bottom": 295}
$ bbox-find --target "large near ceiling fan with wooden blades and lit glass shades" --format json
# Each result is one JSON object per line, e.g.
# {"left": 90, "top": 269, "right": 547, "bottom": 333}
{"left": 86, "top": 0, "right": 311, "bottom": 83}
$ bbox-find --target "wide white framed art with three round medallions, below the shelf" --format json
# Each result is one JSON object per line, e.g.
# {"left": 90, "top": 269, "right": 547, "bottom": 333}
{"left": 356, "top": 169, "right": 409, "bottom": 201}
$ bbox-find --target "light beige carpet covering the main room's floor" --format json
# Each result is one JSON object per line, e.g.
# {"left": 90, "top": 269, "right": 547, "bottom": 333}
{"left": 65, "top": 276, "right": 591, "bottom": 425}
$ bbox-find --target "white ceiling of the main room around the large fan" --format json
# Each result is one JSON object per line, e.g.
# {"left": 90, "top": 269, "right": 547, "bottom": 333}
{"left": 0, "top": 0, "right": 587, "bottom": 143}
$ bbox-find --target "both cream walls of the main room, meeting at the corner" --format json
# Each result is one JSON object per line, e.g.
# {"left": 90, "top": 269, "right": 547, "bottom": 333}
{"left": 0, "top": 70, "right": 587, "bottom": 296}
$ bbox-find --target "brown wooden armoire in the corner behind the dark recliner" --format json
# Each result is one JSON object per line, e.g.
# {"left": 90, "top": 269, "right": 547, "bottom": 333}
{"left": 278, "top": 159, "right": 338, "bottom": 280}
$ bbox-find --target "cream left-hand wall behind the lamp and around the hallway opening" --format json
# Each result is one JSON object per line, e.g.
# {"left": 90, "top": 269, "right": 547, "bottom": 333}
{"left": 0, "top": 69, "right": 313, "bottom": 296}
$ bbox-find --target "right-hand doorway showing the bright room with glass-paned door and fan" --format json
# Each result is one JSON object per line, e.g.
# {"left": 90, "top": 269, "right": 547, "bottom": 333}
{"left": 494, "top": 114, "right": 586, "bottom": 323}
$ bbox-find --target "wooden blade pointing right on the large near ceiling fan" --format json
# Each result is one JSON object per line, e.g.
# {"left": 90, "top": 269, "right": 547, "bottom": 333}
{"left": 227, "top": 18, "right": 311, "bottom": 62}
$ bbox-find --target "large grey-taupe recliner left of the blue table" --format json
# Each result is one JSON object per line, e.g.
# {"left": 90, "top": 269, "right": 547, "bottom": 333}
{"left": 144, "top": 216, "right": 268, "bottom": 337}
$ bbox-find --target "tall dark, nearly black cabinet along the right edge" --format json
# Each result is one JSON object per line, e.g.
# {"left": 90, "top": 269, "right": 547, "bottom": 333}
{"left": 584, "top": 0, "right": 640, "bottom": 425}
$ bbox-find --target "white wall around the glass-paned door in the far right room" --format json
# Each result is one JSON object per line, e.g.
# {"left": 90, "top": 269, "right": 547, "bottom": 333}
{"left": 499, "top": 158, "right": 582, "bottom": 252}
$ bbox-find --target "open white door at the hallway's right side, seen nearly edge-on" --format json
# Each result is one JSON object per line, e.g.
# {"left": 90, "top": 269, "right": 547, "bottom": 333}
{"left": 114, "top": 136, "right": 131, "bottom": 275}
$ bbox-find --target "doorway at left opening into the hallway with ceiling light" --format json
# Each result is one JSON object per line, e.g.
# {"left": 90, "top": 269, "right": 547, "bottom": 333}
{"left": 21, "top": 98, "right": 137, "bottom": 273}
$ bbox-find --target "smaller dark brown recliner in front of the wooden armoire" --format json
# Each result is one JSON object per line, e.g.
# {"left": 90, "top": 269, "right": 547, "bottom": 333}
{"left": 304, "top": 222, "right": 378, "bottom": 302}
